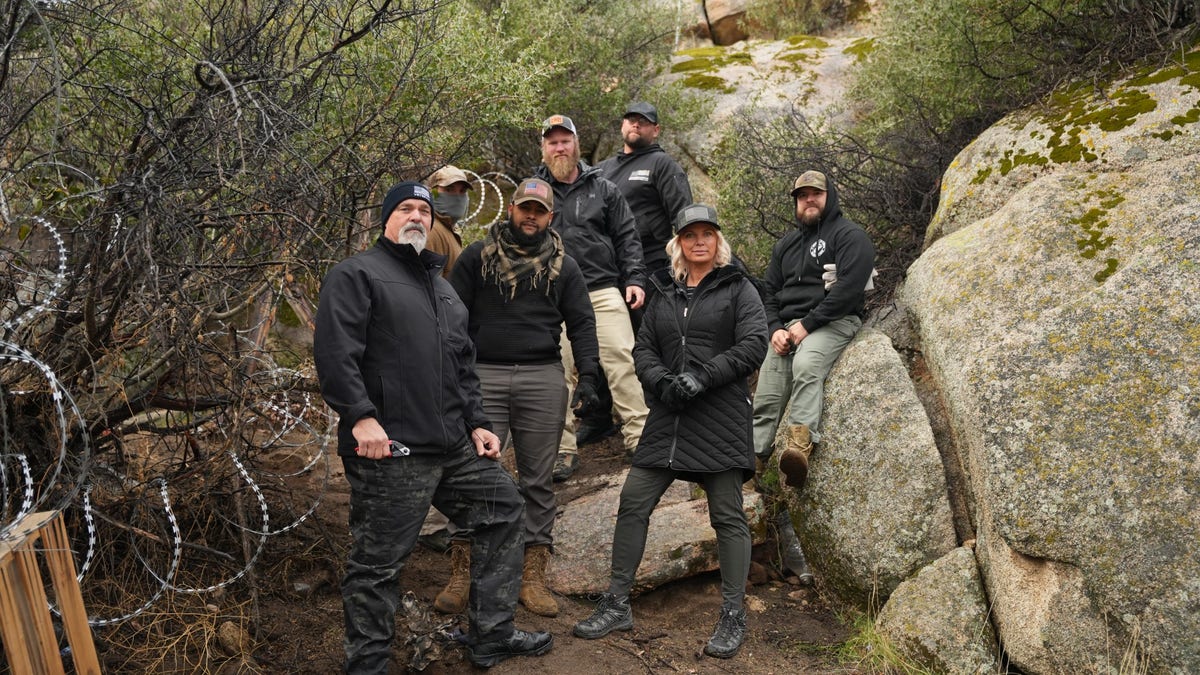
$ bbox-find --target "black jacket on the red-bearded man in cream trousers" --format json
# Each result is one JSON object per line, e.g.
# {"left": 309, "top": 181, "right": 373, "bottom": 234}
{"left": 535, "top": 162, "right": 646, "bottom": 291}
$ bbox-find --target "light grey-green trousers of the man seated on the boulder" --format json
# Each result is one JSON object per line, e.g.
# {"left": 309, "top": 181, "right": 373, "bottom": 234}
{"left": 754, "top": 316, "right": 863, "bottom": 458}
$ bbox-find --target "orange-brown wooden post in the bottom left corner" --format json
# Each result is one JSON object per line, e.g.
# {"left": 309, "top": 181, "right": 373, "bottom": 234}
{"left": 0, "top": 510, "right": 100, "bottom": 675}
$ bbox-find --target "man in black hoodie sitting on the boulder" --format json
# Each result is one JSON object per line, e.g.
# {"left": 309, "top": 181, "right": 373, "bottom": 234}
{"left": 754, "top": 171, "right": 875, "bottom": 571}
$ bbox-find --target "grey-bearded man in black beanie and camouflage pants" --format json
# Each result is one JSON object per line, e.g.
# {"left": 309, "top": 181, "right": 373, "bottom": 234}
{"left": 313, "top": 181, "right": 553, "bottom": 673}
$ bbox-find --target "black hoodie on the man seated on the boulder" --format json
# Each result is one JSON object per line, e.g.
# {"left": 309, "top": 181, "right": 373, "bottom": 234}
{"left": 763, "top": 171, "right": 875, "bottom": 334}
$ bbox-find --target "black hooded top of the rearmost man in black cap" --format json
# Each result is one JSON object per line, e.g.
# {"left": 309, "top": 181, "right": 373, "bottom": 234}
{"left": 596, "top": 143, "right": 691, "bottom": 273}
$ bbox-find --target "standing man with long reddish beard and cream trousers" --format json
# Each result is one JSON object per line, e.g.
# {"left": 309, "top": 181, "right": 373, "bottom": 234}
{"left": 536, "top": 115, "right": 647, "bottom": 480}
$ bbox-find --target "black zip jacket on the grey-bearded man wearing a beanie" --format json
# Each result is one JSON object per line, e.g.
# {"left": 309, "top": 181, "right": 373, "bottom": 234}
{"left": 313, "top": 237, "right": 491, "bottom": 456}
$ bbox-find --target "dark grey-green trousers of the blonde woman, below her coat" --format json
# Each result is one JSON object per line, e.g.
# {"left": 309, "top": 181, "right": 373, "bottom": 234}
{"left": 608, "top": 466, "right": 751, "bottom": 609}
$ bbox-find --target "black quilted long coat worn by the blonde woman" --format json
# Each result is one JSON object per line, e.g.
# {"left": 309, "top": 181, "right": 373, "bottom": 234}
{"left": 634, "top": 265, "right": 767, "bottom": 480}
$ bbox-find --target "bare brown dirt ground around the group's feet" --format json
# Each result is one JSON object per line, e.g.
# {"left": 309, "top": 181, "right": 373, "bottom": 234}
{"left": 242, "top": 429, "right": 859, "bottom": 675}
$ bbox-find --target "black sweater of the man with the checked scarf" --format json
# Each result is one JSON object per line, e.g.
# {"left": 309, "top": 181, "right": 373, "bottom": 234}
{"left": 450, "top": 230, "right": 600, "bottom": 380}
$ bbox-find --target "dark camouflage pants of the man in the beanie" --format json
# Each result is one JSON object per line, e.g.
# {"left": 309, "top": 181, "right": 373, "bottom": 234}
{"left": 342, "top": 443, "right": 524, "bottom": 673}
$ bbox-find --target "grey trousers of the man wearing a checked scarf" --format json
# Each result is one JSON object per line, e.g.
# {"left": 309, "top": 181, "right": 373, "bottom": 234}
{"left": 475, "top": 362, "right": 566, "bottom": 546}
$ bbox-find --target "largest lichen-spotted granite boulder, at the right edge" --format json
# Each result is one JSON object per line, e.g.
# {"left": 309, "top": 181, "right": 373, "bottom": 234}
{"left": 900, "top": 58, "right": 1200, "bottom": 673}
